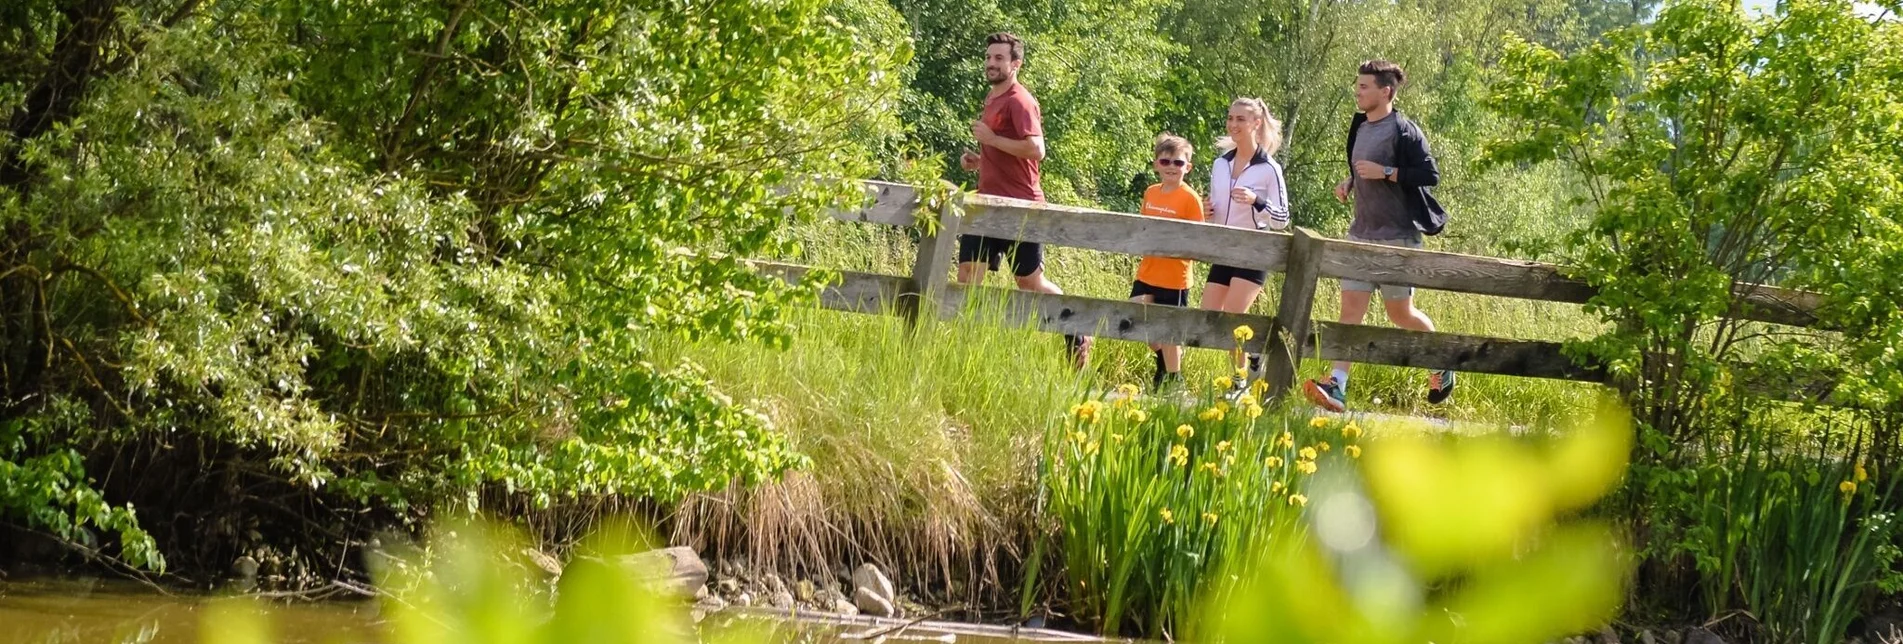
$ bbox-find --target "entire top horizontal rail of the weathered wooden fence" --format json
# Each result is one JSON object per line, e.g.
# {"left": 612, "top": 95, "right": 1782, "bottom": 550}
{"left": 834, "top": 181, "right": 1823, "bottom": 326}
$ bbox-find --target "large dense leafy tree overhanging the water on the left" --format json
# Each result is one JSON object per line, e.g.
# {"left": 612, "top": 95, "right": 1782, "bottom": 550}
{"left": 0, "top": 0, "right": 908, "bottom": 566}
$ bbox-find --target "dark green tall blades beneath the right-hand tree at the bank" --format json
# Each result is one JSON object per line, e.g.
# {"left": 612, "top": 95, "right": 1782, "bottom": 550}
{"left": 1640, "top": 409, "right": 1897, "bottom": 644}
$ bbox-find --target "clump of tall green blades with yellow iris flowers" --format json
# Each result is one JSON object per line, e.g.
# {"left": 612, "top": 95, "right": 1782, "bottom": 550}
{"left": 1039, "top": 371, "right": 1361, "bottom": 638}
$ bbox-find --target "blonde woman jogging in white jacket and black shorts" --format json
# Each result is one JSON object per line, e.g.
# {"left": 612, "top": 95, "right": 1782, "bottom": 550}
{"left": 1203, "top": 97, "right": 1288, "bottom": 392}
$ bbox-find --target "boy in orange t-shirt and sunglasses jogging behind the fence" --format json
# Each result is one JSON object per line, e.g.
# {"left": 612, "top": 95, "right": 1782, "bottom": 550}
{"left": 1130, "top": 133, "right": 1203, "bottom": 389}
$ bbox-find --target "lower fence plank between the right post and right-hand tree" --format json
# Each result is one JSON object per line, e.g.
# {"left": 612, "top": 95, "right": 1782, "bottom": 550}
{"left": 1315, "top": 322, "right": 1604, "bottom": 383}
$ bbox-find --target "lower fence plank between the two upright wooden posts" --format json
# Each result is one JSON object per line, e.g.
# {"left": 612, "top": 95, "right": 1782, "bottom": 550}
{"left": 938, "top": 284, "right": 1271, "bottom": 352}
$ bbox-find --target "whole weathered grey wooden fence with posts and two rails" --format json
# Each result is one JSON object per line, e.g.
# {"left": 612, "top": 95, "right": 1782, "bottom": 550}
{"left": 755, "top": 181, "right": 1829, "bottom": 402}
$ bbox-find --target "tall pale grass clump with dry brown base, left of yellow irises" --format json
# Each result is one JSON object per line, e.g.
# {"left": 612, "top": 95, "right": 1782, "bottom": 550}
{"left": 653, "top": 291, "right": 1089, "bottom": 591}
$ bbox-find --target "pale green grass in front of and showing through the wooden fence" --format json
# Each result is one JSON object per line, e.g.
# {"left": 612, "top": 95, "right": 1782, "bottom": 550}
{"left": 653, "top": 221, "right": 1621, "bottom": 594}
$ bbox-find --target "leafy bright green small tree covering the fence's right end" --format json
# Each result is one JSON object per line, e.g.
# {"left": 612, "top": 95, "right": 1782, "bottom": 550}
{"left": 1490, "top": 0, "right": 1903, "bottom": 453}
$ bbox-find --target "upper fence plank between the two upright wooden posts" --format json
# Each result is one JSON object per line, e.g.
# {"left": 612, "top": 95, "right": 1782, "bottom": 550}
{"left": 965, "top": 194, "right": 1288, "bottom": 271}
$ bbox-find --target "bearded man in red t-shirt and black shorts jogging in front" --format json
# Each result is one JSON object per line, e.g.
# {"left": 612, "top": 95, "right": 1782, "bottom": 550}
{"left": 957, "top": 32, "right": 1090, "bottom": 370}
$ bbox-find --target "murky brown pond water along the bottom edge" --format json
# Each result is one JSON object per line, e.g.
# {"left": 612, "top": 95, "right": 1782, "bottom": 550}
{"left": 0, "top": 579, "right": 1102, "bottom": 644}
